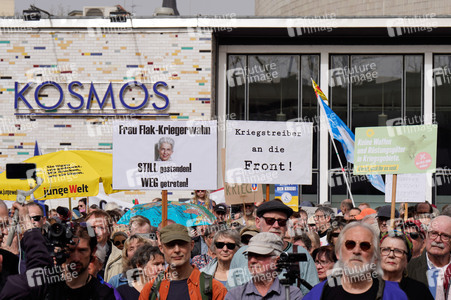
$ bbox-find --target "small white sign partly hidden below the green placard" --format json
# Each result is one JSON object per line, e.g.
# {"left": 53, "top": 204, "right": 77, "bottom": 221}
{"left": 385, "top": 173, "right": 427, "bottom": 203}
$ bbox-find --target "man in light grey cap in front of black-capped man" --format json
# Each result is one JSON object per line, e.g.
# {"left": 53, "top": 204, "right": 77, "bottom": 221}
{"left": 225, "top": 232, "right": 303, "bottom": 300}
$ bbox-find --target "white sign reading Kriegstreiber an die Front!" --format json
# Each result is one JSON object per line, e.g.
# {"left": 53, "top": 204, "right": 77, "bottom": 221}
{"left": 225, "top": 121, "right": 313, "bottom": 184}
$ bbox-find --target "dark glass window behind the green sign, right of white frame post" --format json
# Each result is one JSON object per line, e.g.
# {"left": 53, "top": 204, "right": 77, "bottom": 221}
{"left": 329, "top": 55, "right": 423, "bottom": 207}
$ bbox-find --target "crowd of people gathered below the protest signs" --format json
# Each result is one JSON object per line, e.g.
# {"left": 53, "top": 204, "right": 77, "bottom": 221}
{"left": 0, "top": 190, "right": 451, "bottom": 300}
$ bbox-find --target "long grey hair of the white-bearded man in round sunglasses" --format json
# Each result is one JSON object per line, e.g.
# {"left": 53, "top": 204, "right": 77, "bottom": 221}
{"left": 335, "top": 221, "right": 384, "bottom": 277}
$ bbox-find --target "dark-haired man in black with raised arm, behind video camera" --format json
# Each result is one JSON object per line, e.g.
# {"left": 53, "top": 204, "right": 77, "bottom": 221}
{"left": 0, "top": 203, "right": 115, "bottom": 300}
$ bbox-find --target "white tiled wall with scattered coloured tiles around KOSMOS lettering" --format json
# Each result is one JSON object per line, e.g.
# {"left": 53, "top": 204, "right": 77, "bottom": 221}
{"left": 0, "top": 28, "right": 212, "bottom": 203}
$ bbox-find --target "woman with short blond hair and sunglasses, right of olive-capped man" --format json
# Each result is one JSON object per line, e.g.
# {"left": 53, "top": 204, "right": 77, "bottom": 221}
{"left": 201, "top": 229, "right": 241, "bottom": 289}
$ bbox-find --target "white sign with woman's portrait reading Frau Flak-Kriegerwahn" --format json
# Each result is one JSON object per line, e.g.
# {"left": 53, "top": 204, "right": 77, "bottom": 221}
{"left": 113, "top": 121, "right": 217, "bottom": 190}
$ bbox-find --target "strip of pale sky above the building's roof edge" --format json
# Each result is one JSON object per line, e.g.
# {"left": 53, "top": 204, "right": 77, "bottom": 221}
{"left": 15, "top": 0, "right": 255, "bottom": 16}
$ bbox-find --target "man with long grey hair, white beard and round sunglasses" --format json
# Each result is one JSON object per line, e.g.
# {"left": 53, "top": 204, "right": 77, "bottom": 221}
{"left": 304, "top": 222, "right": 407, "bottom": 300}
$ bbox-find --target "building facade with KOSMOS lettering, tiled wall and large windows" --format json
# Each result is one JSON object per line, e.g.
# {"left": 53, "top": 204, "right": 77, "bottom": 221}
{"left": 0, "top": 17, "right": 451, "bottom": 206}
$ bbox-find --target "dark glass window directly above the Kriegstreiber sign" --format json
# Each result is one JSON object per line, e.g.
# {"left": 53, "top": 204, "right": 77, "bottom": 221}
{"left": 227, "top": 54, "right": 319, "bottom": 203}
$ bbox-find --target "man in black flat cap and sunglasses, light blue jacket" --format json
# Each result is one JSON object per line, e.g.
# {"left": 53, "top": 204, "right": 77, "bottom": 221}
{"left": 228, "top": 200, "right": 319, "bottom": 295}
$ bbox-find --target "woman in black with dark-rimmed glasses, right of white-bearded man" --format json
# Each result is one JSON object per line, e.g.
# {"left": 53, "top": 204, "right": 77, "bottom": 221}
{"left": 380, "top": 230, "right": 434, "bottom": 300}
